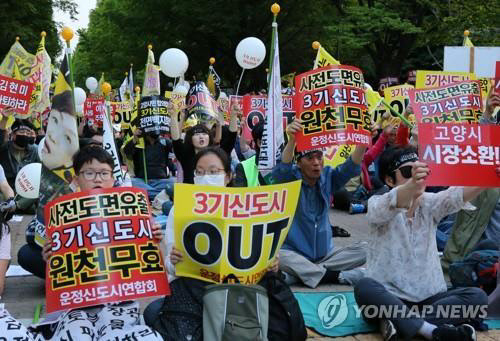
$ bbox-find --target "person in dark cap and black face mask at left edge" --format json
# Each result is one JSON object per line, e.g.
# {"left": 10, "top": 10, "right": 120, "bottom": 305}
{"left": 0, "top": 118, "right": 40, "bottom": 188}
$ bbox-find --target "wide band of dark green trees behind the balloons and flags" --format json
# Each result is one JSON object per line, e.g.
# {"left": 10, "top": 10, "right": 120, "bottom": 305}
{"left": 74, "top": 0, "right": 499, "bottom": 91}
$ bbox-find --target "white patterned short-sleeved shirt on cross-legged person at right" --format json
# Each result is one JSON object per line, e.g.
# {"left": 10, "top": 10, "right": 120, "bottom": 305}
{"left": 366, "top": 187, "right": 472, "bottom": 302}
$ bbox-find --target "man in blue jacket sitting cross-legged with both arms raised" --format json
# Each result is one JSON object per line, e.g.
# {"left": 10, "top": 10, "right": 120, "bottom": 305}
{"left": 272, "top": 119, "right": 366, "bottom": 288}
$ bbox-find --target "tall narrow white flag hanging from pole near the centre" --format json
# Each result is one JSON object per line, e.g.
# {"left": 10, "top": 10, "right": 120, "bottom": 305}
{"left": 259, "top": 23, "right": 285, "bottom": 177}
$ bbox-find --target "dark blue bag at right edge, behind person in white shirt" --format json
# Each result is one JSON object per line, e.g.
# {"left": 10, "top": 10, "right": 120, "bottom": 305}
{"left": 449, "top": 250, "right": 500, "bottom": 294}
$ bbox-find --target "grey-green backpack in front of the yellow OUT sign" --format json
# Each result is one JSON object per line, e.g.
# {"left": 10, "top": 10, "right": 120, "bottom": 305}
{"left": 203, "top": 278, "right": 269, "bottom": 341}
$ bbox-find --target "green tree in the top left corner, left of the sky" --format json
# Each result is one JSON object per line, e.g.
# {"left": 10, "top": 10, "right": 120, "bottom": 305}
{"left": 0, "top": 0, "right": 78, "bottom": 60}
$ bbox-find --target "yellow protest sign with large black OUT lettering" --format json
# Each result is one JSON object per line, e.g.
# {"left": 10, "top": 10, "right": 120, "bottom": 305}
{"left": 174, "top": 181, "right": 301, "bottom": 284}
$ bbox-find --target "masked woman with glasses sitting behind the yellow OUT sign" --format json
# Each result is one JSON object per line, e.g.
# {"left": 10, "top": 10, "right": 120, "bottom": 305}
{"left": 144, "top": 147, "right": 305, "bottom": 340}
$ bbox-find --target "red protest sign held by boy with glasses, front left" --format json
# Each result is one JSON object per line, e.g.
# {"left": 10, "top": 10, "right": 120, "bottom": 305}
{"left": 45, "top": 187, "right": 170, "bottom": 313}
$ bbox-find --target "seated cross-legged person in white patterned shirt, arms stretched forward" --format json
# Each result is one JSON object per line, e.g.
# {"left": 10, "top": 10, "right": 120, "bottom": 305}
{"left": 354, "top": 147, "right": 487, "bottom": 340}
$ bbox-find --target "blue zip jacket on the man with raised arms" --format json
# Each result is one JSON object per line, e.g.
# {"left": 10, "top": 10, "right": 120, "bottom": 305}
{"left": 272, "top": 157, "right": 361, "bottom": 262}
